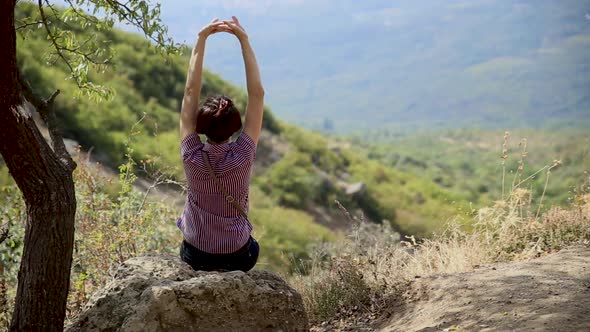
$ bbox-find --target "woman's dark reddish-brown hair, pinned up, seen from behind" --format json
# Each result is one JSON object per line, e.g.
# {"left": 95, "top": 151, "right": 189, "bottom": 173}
{"left": 196, "top": 96, "right": 242, "bottom": 143}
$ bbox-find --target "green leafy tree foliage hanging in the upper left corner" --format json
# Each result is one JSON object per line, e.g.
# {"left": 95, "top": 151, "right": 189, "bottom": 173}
{"left": 16, "top": 0, "right": 180, "bottom": 98}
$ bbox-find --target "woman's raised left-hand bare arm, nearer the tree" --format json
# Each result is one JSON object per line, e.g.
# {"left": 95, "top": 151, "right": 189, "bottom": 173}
{"left": 180, "top": 18, "right": 233, "bottom": 140}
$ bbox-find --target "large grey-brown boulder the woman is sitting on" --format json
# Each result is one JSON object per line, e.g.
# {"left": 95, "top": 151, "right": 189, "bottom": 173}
{"left": 66, "top": 256, "right": 308, "bottom": 332}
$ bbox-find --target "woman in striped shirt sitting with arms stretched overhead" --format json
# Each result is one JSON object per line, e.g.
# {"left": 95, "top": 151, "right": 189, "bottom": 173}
{"left": 177, "top": 17, "right": 264, "bottom": 271}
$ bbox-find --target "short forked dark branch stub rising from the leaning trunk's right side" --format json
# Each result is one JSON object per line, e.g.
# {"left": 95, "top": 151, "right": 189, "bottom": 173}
{"left": 19, "top": 74, "right": 76, "bottom": 171}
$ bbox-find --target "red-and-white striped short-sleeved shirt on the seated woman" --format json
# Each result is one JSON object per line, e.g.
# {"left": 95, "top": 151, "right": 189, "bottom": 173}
{"left": 177, "top": 131, "right": 256, "bottom": 254}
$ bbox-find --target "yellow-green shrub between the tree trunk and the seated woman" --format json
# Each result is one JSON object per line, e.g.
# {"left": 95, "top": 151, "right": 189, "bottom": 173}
{"left": 68, "top": 150, "right": 181, "bottom": 315}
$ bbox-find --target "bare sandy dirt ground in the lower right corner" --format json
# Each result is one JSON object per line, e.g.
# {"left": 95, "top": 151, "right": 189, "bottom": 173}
{"left": 312, "top": 246, "right": 590, "bottom": 332}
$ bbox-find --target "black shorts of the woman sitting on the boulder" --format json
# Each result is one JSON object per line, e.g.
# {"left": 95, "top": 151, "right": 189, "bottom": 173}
{"left": 180, "top": 236, "right": 260, "bottom": 272}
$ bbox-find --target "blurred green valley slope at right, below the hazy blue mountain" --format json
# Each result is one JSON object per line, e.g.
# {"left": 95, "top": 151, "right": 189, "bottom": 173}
{"left": 353, "top": 128, "right": 590, "bottom": 206}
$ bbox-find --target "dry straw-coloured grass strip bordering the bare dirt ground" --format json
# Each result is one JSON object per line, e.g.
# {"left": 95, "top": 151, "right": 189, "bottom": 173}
{"left": 291, "top": 139, "right": 590, "bottom": 322}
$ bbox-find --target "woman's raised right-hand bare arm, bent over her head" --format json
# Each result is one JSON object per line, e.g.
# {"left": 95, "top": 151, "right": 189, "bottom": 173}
{"left": 224, "top": 16, "right": 264, "bottom": 143}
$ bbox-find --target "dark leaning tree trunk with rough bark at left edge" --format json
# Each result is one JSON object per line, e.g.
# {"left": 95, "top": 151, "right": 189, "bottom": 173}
{"left": 0, "top": 0, "right": 76, "bottom": 331}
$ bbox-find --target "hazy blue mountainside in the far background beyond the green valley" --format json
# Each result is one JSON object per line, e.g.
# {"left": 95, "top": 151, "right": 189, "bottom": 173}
{"left": 154, "top": 0, "right": 590, "bottom": 132}
